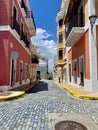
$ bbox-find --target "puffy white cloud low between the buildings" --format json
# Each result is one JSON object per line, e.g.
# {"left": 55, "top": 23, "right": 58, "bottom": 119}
{"left": 31, "top": 28, "right": 57, "bottom": 70}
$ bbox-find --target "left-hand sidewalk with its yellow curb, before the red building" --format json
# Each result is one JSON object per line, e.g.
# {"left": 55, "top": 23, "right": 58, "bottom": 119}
{"left": 0, "top": 81, "right": 38, "bottom": 102}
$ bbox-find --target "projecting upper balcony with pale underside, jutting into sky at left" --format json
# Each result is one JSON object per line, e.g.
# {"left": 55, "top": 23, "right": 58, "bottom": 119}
{"left": 25, "top": 11, "right": 36, "bottom": 36}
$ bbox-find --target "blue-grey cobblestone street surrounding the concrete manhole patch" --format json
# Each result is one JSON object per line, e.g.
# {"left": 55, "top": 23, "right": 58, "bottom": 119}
{"left": 0, "top": 80, "right": 98, "bottom": 130}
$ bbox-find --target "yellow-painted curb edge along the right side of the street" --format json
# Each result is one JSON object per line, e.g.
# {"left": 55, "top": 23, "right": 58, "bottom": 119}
{"left": 54, "top": 81, "right": 98, "bottom": 100}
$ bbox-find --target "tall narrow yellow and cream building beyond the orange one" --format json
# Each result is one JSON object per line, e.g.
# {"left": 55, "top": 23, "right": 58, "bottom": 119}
{"left": 56, "top": 0, "right": 67, "bottom": 83}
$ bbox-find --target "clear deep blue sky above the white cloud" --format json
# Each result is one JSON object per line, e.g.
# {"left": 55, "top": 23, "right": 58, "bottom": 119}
{"left": 29, "top": 0, "right": 61, "bottom": 42}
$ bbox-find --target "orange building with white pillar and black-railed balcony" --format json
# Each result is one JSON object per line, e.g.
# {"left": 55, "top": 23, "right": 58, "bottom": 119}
{"left": 58, "top": 0, "right": 98, "bottom": 92}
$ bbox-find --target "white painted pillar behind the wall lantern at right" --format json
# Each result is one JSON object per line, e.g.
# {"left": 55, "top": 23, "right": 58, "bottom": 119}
{"left": 87, "top": 0, "right": 98, "bottom": 91}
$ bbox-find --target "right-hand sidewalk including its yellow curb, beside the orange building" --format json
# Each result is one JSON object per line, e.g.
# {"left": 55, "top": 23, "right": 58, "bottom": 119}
{"left": 55, "top": 81, "right": 98, "bottom": 100}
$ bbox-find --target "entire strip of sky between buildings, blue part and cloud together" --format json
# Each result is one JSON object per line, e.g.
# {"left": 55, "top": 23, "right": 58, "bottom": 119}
{"left": 29, "top": 0, "right": 61, "bottom": 71}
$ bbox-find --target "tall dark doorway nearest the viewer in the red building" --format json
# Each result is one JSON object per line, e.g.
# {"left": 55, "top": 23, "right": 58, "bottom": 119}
{"left": 11, "top": 59, "right": 16, "bottom": 86}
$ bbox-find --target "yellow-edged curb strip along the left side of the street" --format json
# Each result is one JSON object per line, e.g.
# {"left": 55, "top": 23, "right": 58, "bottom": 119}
{"left": 0, "top": 81, "right": 39, "bottom": 102}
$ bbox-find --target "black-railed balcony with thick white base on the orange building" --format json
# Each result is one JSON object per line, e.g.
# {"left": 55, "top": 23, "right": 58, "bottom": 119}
{"left": 65, "top": 14, "right": 84, "bottom": 47}
